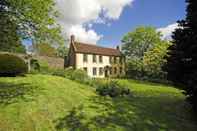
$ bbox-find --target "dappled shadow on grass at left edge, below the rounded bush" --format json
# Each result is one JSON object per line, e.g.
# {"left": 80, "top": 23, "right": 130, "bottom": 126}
{"left": 0, "top": 82, "right": 41, "bottom": 106}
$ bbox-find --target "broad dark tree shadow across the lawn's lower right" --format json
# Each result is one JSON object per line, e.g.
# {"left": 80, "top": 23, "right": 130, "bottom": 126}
{"left": 56, "top": 93, "right": 197, "bottom": 131}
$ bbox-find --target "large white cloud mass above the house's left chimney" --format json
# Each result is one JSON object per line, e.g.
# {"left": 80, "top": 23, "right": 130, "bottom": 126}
{"left": 56, "top": 0, "right": 134, "bottom": 43}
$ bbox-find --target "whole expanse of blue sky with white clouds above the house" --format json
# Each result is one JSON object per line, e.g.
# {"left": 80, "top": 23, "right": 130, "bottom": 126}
{"left": 24, "top": 0, "right": 186, "bottom": 47}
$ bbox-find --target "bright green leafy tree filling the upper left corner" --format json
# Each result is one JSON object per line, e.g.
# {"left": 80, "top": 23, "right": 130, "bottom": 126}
{"left": 0, "top": 0, "right": 63, "bottom": 50}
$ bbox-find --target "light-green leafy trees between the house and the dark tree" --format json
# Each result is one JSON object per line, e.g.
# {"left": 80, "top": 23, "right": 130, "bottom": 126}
{"left": 122, "top": 27, "right": 170, "bottom": 82}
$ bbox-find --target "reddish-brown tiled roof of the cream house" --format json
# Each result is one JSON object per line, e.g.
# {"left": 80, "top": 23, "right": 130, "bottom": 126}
{"left": 73, "top": 42, "right": 122, "bottom": 56}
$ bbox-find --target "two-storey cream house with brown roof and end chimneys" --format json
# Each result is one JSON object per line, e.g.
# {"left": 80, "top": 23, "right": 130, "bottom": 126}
{"left": 67, "top": 35, "right": 125, "bottom": 78}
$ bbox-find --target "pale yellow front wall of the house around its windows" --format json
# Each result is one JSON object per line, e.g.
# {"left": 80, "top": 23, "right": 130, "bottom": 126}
{"left": 76, "top": 53, "right": 125, "bottom": 78}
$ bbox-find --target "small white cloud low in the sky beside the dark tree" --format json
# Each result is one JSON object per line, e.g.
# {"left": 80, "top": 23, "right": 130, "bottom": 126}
{"left": 157, "top": 23, "right": 178, "bottom": 40}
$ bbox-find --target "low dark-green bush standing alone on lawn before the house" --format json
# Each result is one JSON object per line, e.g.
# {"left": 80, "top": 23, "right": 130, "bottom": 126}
{"left": 96, "top": 80, "right": 131, "bottom": 97}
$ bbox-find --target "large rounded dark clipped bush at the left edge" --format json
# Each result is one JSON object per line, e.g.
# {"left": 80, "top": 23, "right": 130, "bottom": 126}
{"left": 0, "top": 54, "right": 28, "bottom": 76}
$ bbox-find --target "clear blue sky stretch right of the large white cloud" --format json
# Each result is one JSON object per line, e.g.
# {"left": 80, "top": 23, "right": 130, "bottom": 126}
{"left": 93, "top": 0, "right": 186, "bottom": 47}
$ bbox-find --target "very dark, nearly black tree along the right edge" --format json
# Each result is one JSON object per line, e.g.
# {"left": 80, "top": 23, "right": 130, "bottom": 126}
{"left": 164, "top": 0, "right": 197, "bottom": 111}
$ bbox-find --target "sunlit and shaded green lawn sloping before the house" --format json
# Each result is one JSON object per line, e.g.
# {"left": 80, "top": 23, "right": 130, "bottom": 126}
{"left": 0, "top": 75, "right": 197, "bottom": 131}
